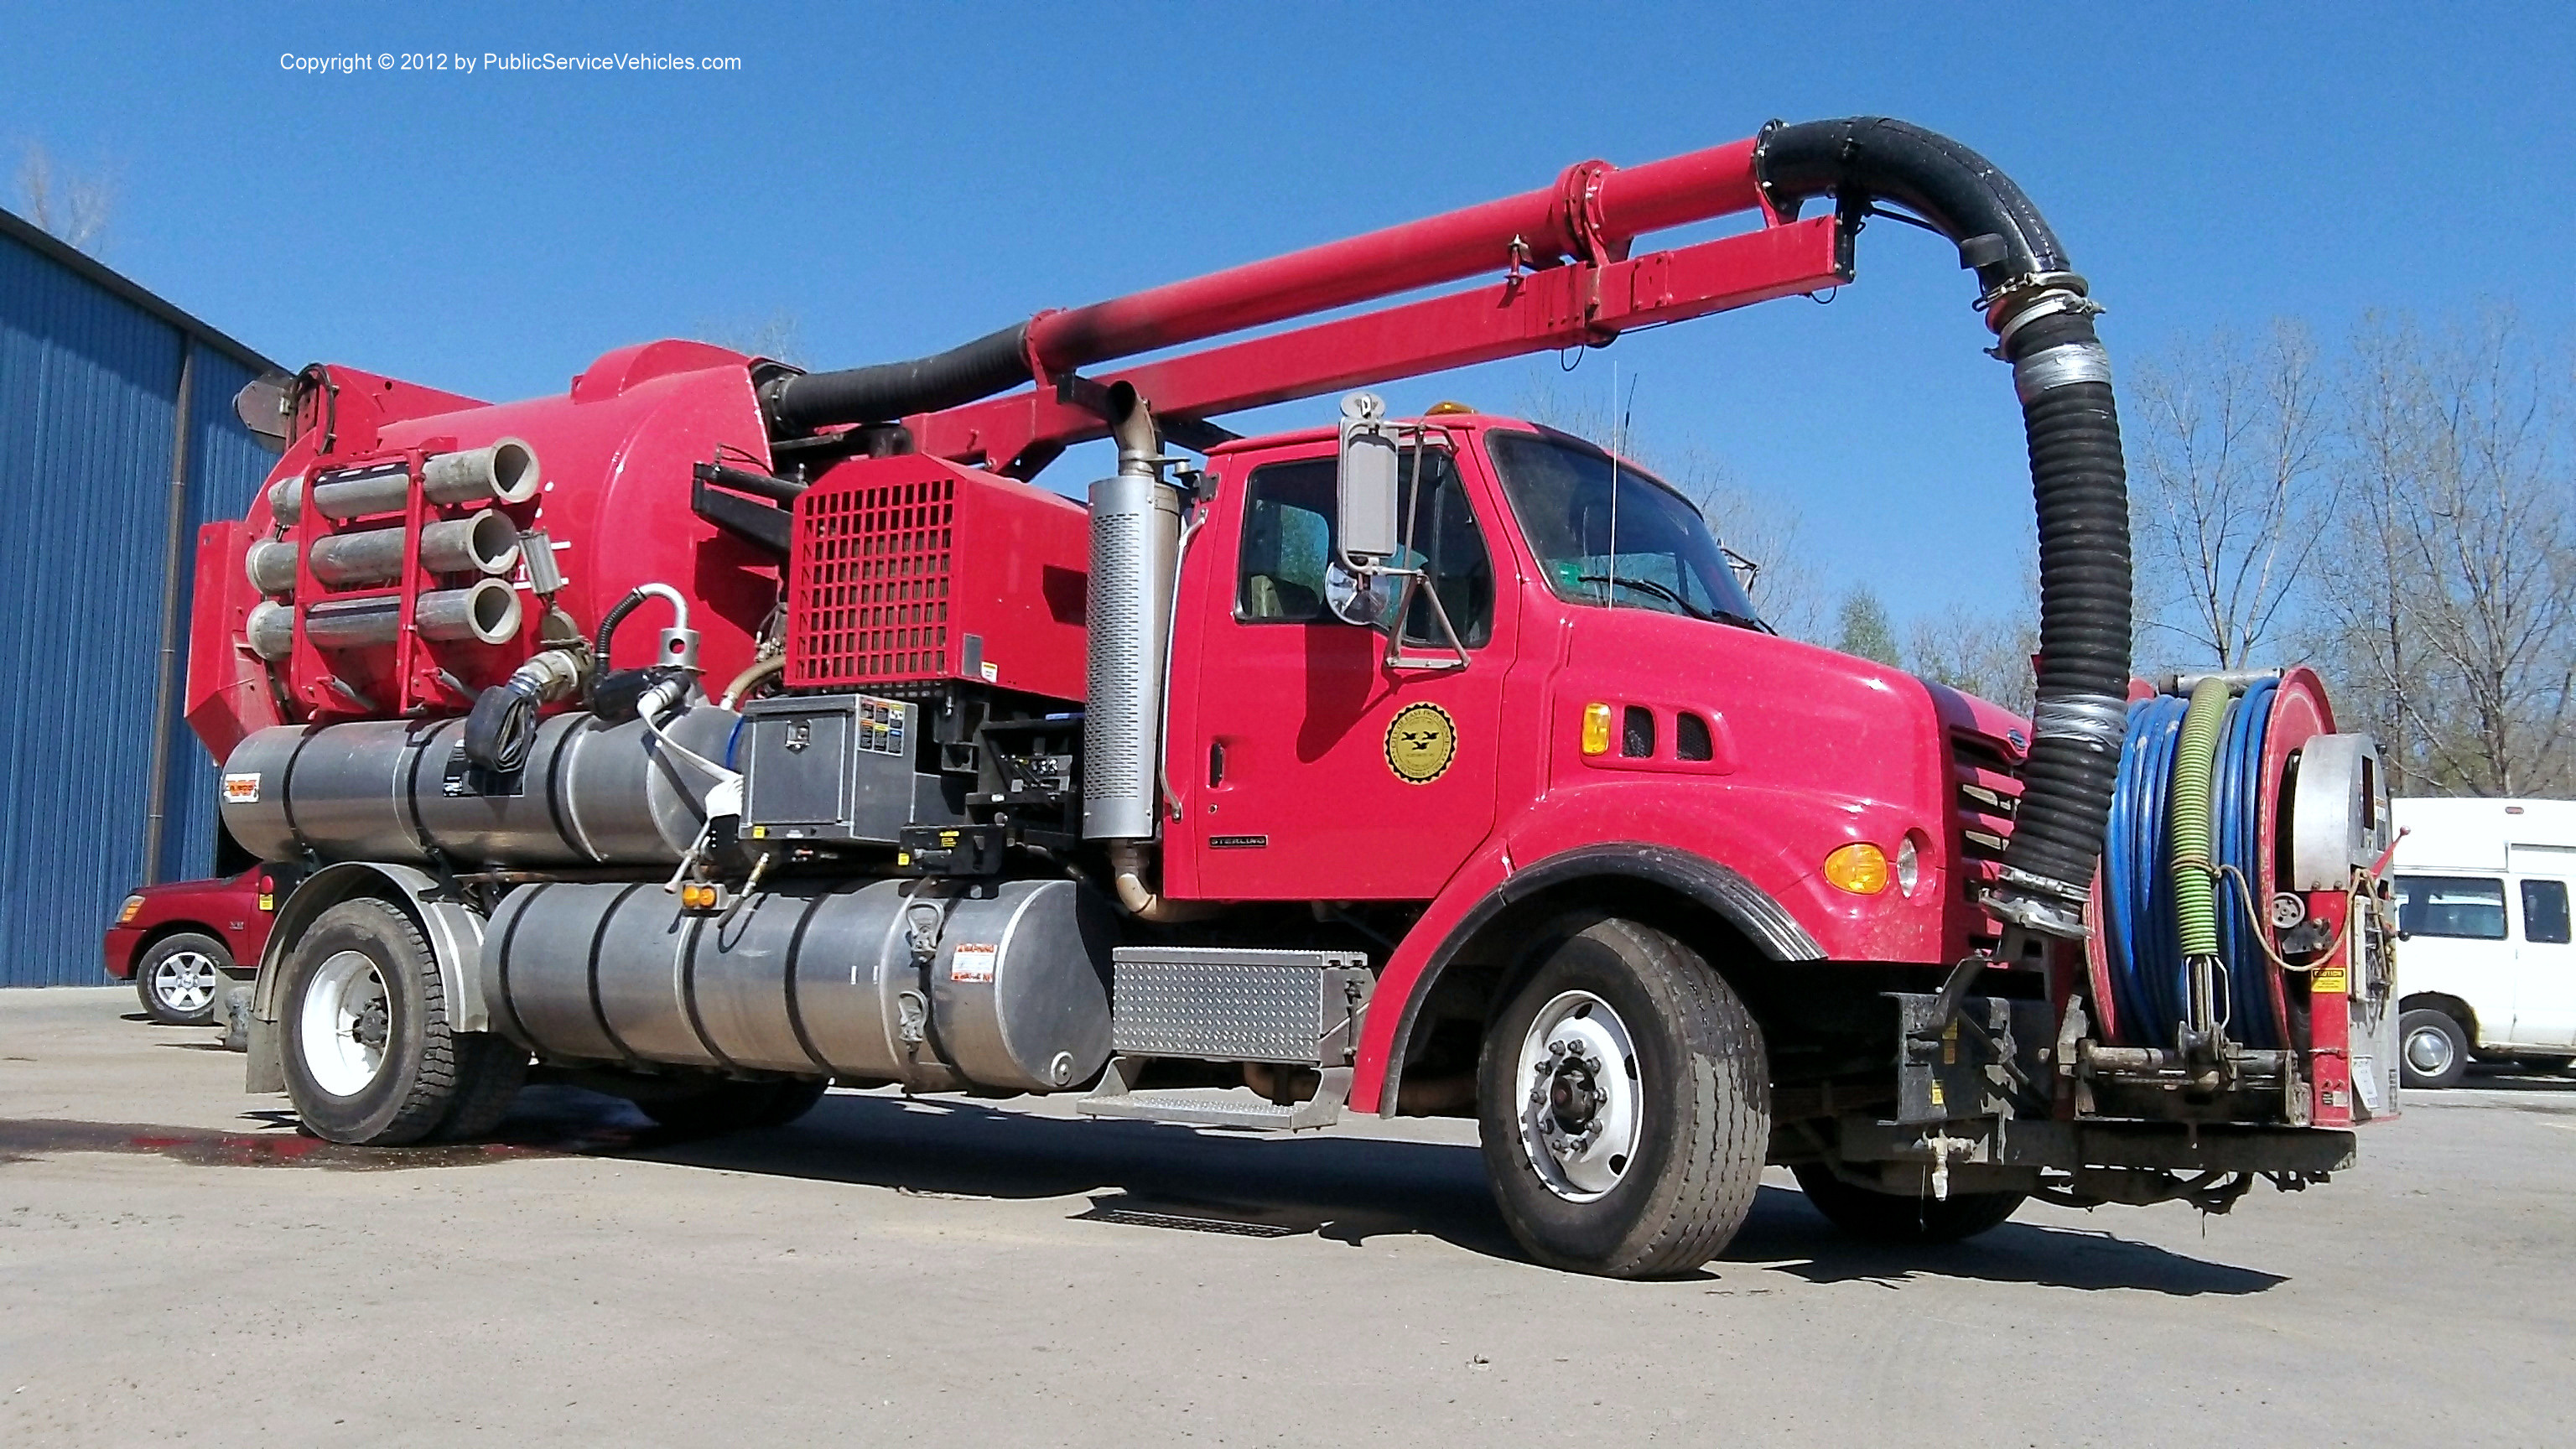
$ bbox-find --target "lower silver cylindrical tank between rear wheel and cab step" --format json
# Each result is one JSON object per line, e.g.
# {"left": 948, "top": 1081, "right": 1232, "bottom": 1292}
{"left": 481, "top": 879, "right": 1113, "bottom": 1091}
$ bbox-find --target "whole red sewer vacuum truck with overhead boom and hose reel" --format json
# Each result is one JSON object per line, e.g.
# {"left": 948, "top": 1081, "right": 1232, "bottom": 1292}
{"left": 188, "top": 118, "right": 2396, "bottom": 1276}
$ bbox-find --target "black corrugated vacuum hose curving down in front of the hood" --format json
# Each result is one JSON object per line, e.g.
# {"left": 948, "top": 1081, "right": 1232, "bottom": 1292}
{"left": 1754, "top": 116, "right": 2131, "bottom": 936}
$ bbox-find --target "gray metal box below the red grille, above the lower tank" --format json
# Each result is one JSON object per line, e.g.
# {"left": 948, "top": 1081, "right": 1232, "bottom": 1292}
{"left": 742, "top": 693, "right": 945, "bottom": 846}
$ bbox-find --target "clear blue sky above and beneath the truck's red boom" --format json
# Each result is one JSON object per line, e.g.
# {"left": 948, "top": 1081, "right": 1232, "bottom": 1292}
{"left": 0, "top": 3, "right": 2576, "bottom": 616}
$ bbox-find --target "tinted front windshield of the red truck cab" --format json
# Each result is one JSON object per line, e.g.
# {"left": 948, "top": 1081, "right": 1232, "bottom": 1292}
{"left": 1487, "top": 434, "right": 1762, "bottom": 629}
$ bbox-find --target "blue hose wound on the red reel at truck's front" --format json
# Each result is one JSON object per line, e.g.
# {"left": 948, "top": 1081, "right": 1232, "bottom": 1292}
{"left": 2102, "top": 681, "right": 2280, "bottom": 1049}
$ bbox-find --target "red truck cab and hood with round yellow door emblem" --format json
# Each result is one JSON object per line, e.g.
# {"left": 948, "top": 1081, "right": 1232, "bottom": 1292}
{"left": 1165, "top": 408, "right": 1988, "bottom": 964}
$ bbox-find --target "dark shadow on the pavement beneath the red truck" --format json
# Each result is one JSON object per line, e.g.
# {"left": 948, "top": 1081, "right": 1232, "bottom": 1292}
{"left": 500, "top": 1085, "right": 2285, "bottom": 1297}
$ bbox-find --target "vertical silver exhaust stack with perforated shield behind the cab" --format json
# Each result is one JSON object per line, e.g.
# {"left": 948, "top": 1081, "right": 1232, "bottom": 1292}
{"left": 1082, "top": 382, "right": 1180, "bottom": 840}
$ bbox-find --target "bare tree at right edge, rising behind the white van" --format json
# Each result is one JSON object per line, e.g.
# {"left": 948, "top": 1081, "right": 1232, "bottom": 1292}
{"left": 2314, "top": 312, "right": 2576, "bottom": 794}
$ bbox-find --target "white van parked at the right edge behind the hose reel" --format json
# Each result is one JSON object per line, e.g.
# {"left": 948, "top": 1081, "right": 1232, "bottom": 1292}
{"left": 2391, "top": 799, "right": 2576, "bottom": 1088}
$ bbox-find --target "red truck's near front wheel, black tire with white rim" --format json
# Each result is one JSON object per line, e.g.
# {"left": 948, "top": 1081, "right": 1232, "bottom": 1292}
{"left": 1476, "top": 916, "right": 1769, "bottom": 1279}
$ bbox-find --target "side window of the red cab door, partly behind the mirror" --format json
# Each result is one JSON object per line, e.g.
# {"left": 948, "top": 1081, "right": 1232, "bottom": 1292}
{"left": 1233, "top": 449, "right": 1494, "bottom": 636}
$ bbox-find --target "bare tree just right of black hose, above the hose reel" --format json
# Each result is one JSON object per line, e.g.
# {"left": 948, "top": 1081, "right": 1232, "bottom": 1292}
{"left": 2131, "top": 322, "right": 2331, "bottom": 667}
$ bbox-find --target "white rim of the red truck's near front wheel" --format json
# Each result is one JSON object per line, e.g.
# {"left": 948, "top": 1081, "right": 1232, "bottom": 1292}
{"left": 1517, "top": 990, "right": 1644, "bottom": 1202}
